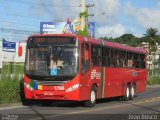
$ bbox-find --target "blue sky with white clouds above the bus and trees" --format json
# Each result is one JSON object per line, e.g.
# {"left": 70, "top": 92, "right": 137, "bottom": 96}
{"left": 0, "top": 0, "right": 160, "bottom": 42}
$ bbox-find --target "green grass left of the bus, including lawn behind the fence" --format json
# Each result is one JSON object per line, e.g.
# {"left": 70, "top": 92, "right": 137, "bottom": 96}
{"left": 0, "top": 63, "right": 24, "bottom": 104}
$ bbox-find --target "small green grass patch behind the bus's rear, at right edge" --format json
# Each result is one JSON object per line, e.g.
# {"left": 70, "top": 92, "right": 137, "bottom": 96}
{"left": 147, "top": 76, "right": 160, "bottom": 85}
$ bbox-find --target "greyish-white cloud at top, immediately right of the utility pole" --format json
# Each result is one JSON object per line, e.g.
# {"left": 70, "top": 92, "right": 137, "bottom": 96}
{"left": 89, "top": 0, "right": 120, "bottom": 25}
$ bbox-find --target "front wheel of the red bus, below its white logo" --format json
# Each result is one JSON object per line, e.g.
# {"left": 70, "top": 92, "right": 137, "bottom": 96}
{"left": 84, "top": 86, "right": 97, "bottom": 107}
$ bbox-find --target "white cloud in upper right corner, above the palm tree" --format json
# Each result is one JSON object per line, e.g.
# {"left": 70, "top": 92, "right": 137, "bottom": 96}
{"left": 124, "top": 3, "right": 160, "bottom": 30}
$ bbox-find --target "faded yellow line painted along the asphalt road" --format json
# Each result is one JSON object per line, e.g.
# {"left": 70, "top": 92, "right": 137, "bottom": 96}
{"left": 30, "top": 97, "right": 160, "bottom": 120}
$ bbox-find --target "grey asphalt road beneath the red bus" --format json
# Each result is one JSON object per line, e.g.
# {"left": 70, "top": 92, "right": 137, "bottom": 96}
{"left": 0, "top": 87, "right": 160, "bottom": 120}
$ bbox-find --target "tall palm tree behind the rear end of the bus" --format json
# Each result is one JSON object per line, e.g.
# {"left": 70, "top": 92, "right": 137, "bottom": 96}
{"left": 145, "top": 27, "right": 159, "bottom": 54}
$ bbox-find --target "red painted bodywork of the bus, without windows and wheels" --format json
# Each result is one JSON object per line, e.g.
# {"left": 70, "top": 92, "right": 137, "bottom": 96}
{"left": 24, "top": 34, "right": 147, "bottom": 101}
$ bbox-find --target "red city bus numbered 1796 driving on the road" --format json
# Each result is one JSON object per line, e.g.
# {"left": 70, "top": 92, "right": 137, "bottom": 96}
{"left": 22, "top": 34, "right": 147, "bottom": 107}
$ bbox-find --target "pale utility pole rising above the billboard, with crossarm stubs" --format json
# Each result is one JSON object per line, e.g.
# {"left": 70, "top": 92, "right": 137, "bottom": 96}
{"left": 80, "top": 0, "right": 94, "bottom": 31}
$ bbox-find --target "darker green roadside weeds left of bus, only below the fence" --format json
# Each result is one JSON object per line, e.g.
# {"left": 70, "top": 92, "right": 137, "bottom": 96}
{"left": 0, "top": 79, "right": 20, "bottom": 104}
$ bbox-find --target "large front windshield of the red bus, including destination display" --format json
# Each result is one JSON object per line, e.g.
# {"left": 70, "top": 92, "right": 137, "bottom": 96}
{"left": 25, "top": 37, "right": 78, "bottom": 79}
